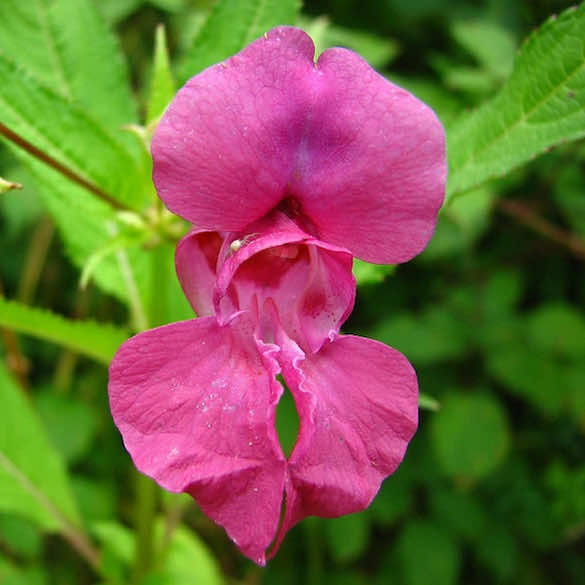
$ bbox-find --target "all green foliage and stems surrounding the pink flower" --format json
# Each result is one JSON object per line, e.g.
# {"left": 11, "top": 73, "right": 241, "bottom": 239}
{"left": 0, "top": 0, "right": 585, "bottom": 585}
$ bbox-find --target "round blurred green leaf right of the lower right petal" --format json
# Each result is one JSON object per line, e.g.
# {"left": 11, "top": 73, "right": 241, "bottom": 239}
{"left": 432, "top": 394, "right": 510, "bottom": 480}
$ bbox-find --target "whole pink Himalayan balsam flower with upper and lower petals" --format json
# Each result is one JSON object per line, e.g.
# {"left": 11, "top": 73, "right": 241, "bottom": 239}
{"left": 109, "top": 27, "right": 446, "bottom": 564}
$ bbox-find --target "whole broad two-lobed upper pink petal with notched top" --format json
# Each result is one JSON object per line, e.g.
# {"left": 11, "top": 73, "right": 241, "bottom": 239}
{"left": 152, "top": 27, "right": 446, "bottom": 263}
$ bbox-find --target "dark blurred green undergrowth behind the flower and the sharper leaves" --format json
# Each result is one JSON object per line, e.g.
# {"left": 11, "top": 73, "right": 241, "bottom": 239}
{"left": 0, "top": 0, "right": 585, "bottom": 585}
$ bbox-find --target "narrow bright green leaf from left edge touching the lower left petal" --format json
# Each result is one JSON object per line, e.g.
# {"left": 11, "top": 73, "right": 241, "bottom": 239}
{"left": 0, "top": 297, "right": 129, "bottom": 364}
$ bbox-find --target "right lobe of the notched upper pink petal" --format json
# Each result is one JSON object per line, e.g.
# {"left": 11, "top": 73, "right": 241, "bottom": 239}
{"left": 290, "top": 49, "right": 447, "bottom": 264}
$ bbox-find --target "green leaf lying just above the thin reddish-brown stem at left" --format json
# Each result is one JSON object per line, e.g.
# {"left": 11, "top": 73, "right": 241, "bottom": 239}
{"left": 0, "top": 53, "right": 149, "bottom": 208}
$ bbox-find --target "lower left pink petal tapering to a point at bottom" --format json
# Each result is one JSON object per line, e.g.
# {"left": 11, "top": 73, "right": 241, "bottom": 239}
{"left": 109, "top": 317, "right": 285, "bottom": 564}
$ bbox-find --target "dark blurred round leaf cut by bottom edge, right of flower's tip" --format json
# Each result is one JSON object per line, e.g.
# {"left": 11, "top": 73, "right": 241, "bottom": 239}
{"left": 397, "top": 520, "right": 462, "bottom": 585}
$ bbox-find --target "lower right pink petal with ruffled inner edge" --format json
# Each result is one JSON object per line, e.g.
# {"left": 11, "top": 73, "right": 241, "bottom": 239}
{"left": 275, "top": 335, "right": 418, "bottom": 548}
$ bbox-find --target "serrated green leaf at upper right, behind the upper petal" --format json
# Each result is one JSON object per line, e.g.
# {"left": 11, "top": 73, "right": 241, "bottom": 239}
{"left": 447, "top": 4, "right": 585, "bottom": 198}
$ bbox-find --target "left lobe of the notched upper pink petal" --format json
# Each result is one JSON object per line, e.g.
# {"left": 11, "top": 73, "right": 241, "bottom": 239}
{"left": 152, "top": 28, "right": 314, "bottom": 231}
